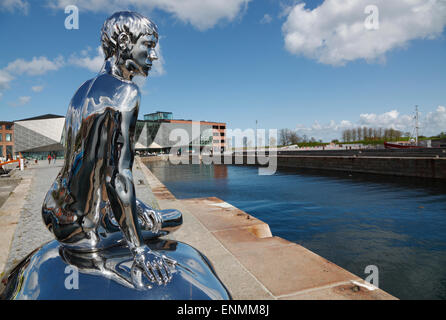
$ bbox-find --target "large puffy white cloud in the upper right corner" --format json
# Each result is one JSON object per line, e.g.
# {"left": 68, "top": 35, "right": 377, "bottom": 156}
{"left": 282, "top": 0, "right": 446, "bottom": 65}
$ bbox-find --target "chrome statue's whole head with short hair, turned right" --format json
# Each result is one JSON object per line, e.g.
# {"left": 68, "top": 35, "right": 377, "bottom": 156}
{"left": 101, "top": 11, "right": 158, "bottom": 79}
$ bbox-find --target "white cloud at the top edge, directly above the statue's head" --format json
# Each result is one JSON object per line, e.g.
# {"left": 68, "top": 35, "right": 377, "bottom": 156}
{"left": 47, "top": 0, "right": 251, "bottom": 30}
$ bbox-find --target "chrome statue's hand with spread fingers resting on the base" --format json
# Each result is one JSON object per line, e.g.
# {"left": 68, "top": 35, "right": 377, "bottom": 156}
{"left": 134, "top": 246, "right": 176, "bottom": 286}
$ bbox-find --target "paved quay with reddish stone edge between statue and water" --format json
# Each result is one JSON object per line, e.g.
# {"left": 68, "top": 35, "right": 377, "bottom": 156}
{"left": 137, "top": 158, "right": 396, "bottom": 300}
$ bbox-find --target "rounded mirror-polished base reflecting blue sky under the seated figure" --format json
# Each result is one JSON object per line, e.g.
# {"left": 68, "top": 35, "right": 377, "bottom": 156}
{"left": 0, "top": 239, "right": 231, "bottom": 300}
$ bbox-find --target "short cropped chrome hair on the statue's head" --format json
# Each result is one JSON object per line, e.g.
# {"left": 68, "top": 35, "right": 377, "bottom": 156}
{"left": 101, "top": 11, "right": 158, "bottom": 59}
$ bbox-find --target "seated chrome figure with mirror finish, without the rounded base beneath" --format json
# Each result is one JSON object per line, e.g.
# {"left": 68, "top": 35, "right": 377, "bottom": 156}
{"left": 42, "top": 12, "right": 174, "bottom": 284}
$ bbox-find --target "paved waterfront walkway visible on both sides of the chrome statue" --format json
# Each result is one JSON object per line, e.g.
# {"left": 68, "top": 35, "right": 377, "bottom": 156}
{"left": 0, "top": 157, "right": 394, "bottom": 300}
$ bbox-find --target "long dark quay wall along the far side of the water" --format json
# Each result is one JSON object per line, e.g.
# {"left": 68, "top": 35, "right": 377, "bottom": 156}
{"left": 155, "top": 148, "right": 446, "bottom": 179}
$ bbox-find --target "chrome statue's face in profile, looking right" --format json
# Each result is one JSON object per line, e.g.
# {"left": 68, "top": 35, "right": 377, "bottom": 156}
{"left": 130, "top": 35, "right": 158, "bottom": 77}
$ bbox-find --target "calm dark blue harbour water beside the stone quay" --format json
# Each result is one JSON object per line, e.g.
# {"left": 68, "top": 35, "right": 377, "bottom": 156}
{"left": 149, "top": 162, "right": 446, "bottom": 299}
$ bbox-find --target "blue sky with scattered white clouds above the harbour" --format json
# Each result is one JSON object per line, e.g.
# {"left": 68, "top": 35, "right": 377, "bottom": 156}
{"left": 0, "top": 0, "right": 446, "bottom": 140}
